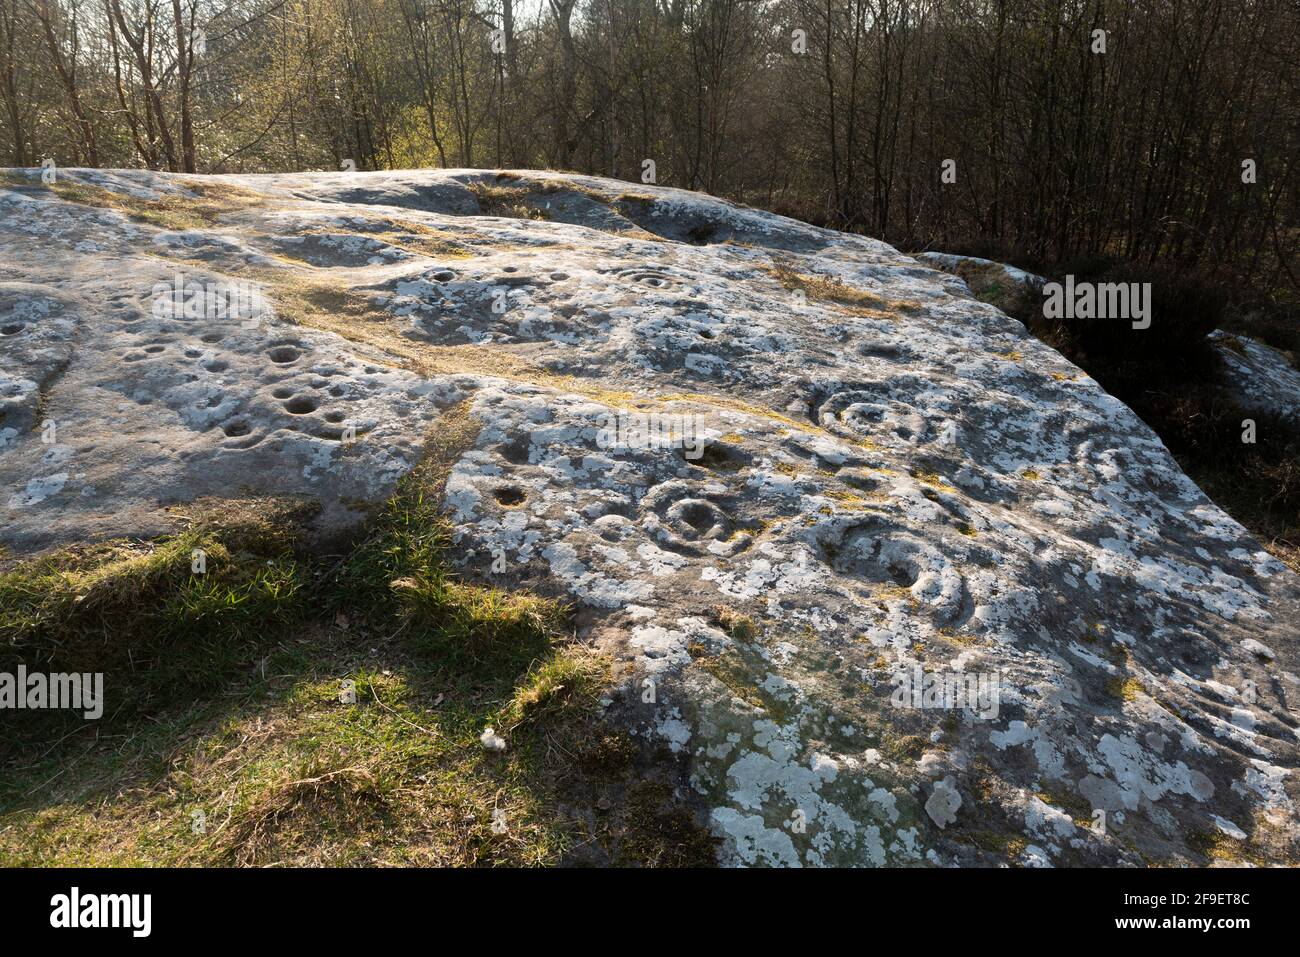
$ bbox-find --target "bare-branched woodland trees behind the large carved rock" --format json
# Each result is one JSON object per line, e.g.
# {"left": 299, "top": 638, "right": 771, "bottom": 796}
{"left": 0, "top": 0, "right": 1300, "bottom": 304}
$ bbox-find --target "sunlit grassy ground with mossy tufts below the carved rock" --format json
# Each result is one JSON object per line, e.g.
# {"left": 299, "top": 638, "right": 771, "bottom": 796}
{"left": 0, "top": 411, "right": 712, "bottom": 865}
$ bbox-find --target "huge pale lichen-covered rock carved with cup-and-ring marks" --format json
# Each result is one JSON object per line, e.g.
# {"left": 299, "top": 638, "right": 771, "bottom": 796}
{"left": 0, "top": 170, "right": 1300, "bottom": 866}
